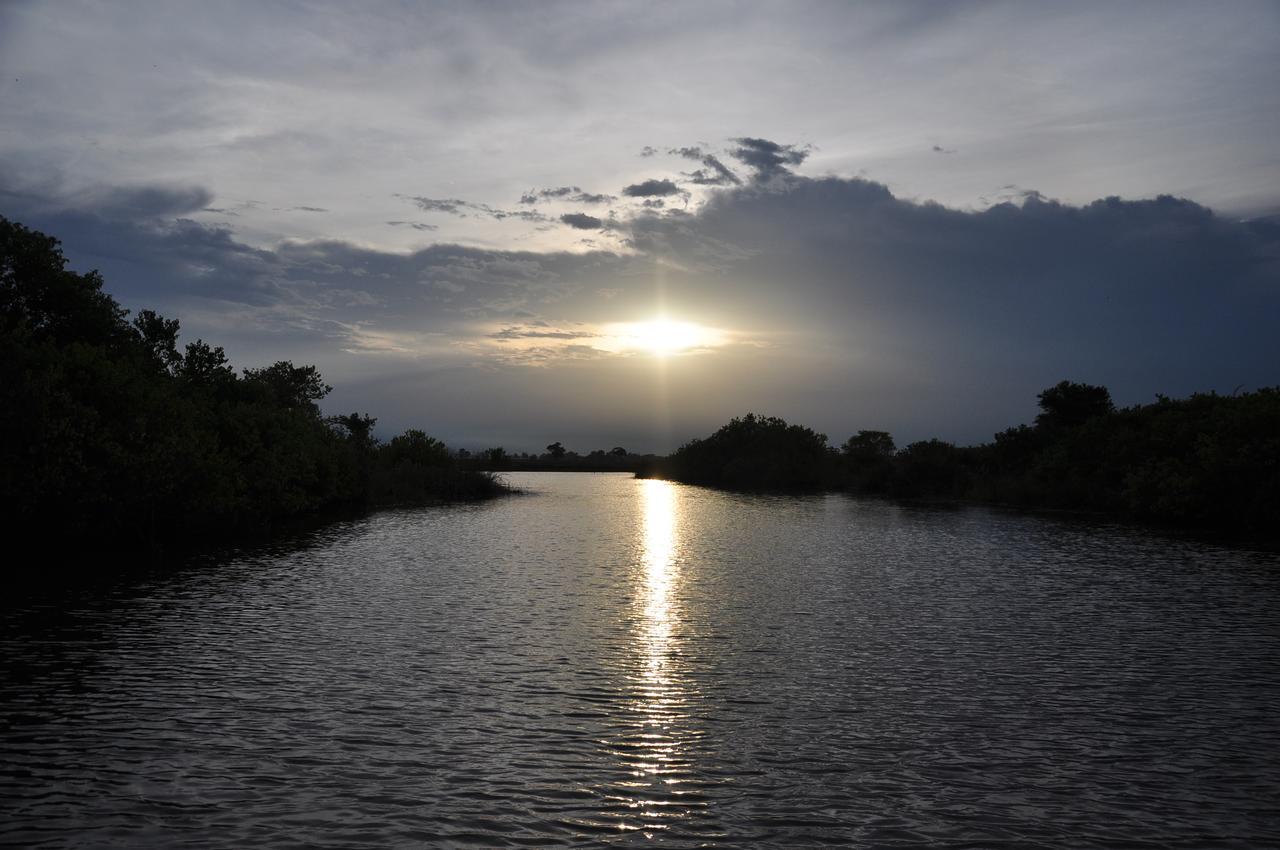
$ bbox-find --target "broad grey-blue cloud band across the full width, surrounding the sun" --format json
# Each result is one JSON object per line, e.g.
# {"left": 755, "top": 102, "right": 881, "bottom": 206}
{"left": 0, "top": 161, "right": 1280, "bottom": 448}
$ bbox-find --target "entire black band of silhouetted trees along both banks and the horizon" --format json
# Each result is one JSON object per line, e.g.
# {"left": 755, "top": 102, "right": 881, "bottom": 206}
{"left": 0, "top": 216, "right": 1280, "bottom": 558}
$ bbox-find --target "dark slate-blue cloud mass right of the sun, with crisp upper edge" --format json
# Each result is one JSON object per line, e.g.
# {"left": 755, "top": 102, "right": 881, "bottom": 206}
{"left": 626, "top": 178, "right": 1280, "bottom": 397}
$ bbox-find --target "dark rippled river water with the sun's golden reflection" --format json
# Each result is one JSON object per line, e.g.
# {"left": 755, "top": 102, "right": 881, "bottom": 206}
{"left": 0, "top": 474, "right": 1280, "bottom": 847}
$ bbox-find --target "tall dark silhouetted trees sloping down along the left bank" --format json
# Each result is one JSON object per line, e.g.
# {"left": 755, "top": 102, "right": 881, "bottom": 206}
{"left": 0, "top": 218, "right": 504, "bottom": 549}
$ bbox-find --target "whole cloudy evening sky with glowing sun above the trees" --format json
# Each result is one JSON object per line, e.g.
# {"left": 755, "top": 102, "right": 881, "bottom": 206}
{"left": 0, "top": 0, "right": 1280, "bottom": 453}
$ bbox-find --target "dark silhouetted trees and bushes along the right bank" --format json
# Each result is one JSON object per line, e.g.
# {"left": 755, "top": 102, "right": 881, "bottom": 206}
{"left": 649, "top": 381, "right": 1280, "bottom": 538}
